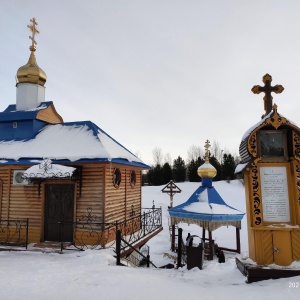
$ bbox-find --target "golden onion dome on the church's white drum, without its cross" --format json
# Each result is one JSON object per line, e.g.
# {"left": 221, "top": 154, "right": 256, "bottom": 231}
{"left": 17, "top": 46, "right": 47, "bottom": 86}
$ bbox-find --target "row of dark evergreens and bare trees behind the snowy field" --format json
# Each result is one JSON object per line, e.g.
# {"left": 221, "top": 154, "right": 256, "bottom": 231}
{"left": 143, "top": 142, "right": 240, "bottom": 185}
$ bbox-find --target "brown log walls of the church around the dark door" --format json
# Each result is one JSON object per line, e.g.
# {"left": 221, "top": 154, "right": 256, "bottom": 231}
{"left": 0, "top": 163, "right": 142, "bottom": 242}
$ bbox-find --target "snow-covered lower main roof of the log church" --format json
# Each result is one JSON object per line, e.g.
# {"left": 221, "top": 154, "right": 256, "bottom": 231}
{"left": 0, "top": 121, "right": 148, "bottom": 167}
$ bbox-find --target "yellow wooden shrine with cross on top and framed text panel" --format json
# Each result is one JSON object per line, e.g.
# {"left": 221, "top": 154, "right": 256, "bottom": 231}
{"left": 236, "top": 74, "right": 300, "bottom": 268}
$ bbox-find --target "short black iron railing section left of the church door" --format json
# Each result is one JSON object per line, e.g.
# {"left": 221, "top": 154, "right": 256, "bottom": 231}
{"left": 0, "top": 219, "right": 29, "bottom": 249}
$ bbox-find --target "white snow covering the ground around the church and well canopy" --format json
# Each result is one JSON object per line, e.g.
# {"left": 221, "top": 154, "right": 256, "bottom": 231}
{"left": 0, "top": 180, "right": 300, "bottom": 300}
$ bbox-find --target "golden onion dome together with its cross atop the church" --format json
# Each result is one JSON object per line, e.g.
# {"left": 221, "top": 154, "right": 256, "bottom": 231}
{"left": 16, "top": 18, "right": 47, "bottom": 86}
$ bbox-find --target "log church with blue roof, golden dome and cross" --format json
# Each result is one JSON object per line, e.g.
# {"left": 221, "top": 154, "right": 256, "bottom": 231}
{"left": 0, "top": 18, "right": 155, "bottom": 248}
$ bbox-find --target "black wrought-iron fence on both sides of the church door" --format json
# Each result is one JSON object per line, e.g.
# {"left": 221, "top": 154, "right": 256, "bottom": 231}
{"left": 0, "top": 206, "right": 162, "bottom": 251}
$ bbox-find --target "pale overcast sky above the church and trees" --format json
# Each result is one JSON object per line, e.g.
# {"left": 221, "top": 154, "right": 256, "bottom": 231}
{"left": 0, "top": 0, "right": 300, "bottom": 164}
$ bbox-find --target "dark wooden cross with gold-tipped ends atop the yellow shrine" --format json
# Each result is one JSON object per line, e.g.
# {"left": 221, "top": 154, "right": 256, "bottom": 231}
{"left": 251, "top": 74, "right": 284, "bottom": 116}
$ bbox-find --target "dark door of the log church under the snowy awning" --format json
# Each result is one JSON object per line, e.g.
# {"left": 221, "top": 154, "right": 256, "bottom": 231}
{"left": 44, "top": 184, "right": 74, "bottom": 242}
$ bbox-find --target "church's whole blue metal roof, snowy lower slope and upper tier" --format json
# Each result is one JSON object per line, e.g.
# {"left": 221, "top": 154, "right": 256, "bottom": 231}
{"left": 0, "top": 101, "right": 150, "bottom": 168}
